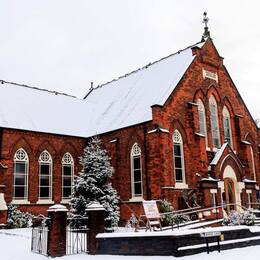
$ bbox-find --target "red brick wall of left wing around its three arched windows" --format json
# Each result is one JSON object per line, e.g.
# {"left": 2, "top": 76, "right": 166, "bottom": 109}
{"left": 0, "top": 129, "right": 86, "bottom": 213}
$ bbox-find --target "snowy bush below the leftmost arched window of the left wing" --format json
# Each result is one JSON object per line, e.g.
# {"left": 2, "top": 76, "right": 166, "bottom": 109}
{"left": 7, "top": 204, "right": 33, "bottom": 228}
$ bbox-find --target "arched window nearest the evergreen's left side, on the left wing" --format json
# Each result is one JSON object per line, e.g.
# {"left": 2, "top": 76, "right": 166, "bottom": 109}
{"left": 62, "top": 153, "right": 74, "bottom": 199}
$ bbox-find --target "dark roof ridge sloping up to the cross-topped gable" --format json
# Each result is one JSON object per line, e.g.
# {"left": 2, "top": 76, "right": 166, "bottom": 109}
{"left": 83, "top": 41, "right": 203, "bottom": 99}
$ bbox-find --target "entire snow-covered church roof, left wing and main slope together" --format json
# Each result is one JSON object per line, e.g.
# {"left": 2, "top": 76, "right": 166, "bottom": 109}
{"left": 0, "top": 43, "right": 203, "bottom": 137}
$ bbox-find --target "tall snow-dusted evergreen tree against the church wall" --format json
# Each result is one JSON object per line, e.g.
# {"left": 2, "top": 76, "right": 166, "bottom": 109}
{"left": 71, "top": 137, "right": 119, "bottom": 230}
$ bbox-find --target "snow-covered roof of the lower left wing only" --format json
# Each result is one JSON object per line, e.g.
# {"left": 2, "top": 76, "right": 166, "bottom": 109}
{"left": 0, "top": 83, "right": 87, "bottom": 137}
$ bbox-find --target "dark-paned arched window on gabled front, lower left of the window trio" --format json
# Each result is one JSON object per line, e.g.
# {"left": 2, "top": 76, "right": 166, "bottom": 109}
{"left": 173, "top": 130, "right": 186, "bottom": 183}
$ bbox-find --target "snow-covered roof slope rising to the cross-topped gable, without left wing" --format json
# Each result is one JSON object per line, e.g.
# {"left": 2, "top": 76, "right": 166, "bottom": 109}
{"left": 86, "top": 43, "right": 202, "bottom": 135}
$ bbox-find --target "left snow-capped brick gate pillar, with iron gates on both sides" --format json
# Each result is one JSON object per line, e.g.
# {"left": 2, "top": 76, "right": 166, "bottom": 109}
{"left": 47, "top": 204, "right": 68, "bottom": 257}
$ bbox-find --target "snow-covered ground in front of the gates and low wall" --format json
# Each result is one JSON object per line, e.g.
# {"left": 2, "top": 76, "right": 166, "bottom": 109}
{"left": 0, "top": 229, "right": 260, "bottom": 260}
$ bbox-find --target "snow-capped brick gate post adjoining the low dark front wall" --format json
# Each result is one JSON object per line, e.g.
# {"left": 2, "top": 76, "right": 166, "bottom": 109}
{"left": 86, "top": 201, "right": 105, "bottom": 255}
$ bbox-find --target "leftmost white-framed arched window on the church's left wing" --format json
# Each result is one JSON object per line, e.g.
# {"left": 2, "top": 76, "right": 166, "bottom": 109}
{"left": 13, "top": 148, "right": 29, "bottom": 200}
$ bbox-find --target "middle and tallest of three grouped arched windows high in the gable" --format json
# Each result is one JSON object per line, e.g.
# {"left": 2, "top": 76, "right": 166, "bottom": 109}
{"left": 209, "top": 96, "right": 220, "bottom": 148}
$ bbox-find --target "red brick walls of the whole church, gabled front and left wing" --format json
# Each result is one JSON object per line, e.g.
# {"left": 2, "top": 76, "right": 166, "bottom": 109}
{"left": 0, "top": 40, "right": 260, "bottom": 219}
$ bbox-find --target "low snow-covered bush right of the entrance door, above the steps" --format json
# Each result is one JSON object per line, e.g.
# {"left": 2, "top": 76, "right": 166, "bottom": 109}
{"left": 222, "top": 210, "right": 255, "bottom": 226}
